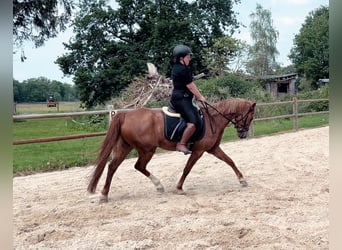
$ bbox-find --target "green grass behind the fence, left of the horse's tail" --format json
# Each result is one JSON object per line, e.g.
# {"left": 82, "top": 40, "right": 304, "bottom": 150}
{"left": 13, "top": 116, "right": 107, "bottom": 174}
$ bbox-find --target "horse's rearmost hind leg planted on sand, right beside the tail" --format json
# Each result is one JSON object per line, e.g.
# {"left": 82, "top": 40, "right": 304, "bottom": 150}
{"left": 100, "top": 147, "right": 132, "bottom": 203}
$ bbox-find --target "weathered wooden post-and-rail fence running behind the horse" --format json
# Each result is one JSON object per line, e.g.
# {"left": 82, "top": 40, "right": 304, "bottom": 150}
{"left": 13, "top": 98, "right": 329, "bottom": 145}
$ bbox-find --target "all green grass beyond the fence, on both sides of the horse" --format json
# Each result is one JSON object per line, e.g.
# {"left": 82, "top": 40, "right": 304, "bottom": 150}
{"left": 13, "top": 103, "right": 329, "bottom": 175}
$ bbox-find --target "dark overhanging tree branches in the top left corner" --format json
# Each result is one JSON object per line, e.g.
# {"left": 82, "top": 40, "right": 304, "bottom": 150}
{"left": 13, "top": 0, "right": 74, "bottom": 61}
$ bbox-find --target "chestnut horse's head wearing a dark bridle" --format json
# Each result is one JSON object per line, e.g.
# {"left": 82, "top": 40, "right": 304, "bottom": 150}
{"left": 233, "top": 102, "right": 256, "bottom": 139}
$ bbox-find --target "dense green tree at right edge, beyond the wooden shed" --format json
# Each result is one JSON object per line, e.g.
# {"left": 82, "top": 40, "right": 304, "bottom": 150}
{"left": 289, "top": 6, "right": 329, "bottom": 87}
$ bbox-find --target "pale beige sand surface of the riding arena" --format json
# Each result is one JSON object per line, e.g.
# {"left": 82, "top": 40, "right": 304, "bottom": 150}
{"left": 13, "top": 127, "right": 329, "bottom": 250}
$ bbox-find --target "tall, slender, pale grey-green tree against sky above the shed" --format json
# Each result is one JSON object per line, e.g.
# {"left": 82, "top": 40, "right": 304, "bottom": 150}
{"left": 246, "top": 4, "right": 279, "bottom": 76}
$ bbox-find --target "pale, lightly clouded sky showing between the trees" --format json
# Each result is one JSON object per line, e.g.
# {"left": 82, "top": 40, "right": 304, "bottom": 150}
{"left": 13, "top": 0, "right": 329, "bottom": 84}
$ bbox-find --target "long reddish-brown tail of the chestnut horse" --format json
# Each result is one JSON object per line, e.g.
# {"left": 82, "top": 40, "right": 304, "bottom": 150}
{"left": 87, "top": 113, "right": 124, "bottom": 193}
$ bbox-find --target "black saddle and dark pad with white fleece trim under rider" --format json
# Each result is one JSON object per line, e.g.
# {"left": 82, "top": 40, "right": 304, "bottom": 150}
{"left": 162, "top": 103, "right": 205, "bottom": 149}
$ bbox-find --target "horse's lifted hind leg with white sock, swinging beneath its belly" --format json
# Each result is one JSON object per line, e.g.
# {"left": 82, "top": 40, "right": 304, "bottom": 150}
{"left": 134, "top": 149, "right": 164, "bottom": 193}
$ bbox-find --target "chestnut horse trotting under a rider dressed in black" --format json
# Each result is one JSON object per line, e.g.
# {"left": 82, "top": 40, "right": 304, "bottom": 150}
{"left": 88, "top": 98, "right": 256, "bottom": 202}
